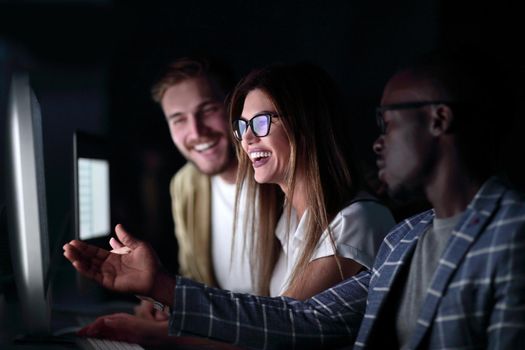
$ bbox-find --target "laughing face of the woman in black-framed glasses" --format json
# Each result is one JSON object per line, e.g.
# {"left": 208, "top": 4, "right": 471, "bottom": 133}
{"left": 242, "top": 89, "right": 291, "bottom": 188}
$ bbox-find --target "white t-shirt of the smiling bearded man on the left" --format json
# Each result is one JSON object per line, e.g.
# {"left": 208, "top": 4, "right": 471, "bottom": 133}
{"left": 211, "top": 176, "right": 255, "bottom": 294}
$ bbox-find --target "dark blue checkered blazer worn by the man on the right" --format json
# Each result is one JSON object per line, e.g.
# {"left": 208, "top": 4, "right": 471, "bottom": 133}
{"left": 170, "top": 178, "right": 525, "bottom": 349}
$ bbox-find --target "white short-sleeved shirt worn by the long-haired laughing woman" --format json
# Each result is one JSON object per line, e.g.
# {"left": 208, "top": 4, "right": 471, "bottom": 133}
{"left": 270, "top": 196, "right": 395, "bottom": 296}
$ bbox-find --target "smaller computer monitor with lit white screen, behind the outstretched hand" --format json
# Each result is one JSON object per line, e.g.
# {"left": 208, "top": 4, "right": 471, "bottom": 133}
{"left": 73, "top": 131, "right": 111, "bottom": 246}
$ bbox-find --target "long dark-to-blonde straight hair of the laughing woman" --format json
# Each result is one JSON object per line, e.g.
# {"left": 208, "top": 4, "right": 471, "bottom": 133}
{"left": 229, "top": 63, "right": 361, "bottom": 295}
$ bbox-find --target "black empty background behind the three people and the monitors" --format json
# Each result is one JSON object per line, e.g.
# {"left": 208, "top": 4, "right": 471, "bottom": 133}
{"left": 0, "top": 0, "right": 525, "bottom": 269}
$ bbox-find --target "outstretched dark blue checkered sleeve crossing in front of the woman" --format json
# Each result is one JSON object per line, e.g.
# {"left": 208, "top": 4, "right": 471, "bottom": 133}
{"left": 169, "top": 271, "right": 370, "bottom": 349}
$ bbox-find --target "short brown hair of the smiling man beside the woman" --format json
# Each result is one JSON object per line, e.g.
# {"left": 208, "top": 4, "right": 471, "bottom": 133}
{"left": 151, "top": 57, "right": 235, "bottom": 103}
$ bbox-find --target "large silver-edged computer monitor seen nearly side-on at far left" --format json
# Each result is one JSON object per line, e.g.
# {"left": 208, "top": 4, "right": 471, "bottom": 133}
{"left": 3, "top": 73, "right": 51, "bottom": 335}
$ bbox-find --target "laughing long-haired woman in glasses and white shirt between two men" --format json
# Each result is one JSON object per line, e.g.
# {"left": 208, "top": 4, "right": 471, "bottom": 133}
{"left": 230, "top": 64, "right": 395, "bottom": 299}
